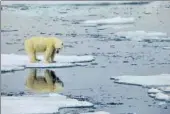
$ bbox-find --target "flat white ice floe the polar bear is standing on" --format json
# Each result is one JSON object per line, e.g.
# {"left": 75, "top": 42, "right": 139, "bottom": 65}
{"left": 1, "top": 54, "right": 95, "bottom": 71}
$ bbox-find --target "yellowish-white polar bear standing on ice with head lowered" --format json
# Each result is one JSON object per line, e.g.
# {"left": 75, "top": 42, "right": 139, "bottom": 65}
{"left": 24, "top": 37, "right": 63, "bottom": 63}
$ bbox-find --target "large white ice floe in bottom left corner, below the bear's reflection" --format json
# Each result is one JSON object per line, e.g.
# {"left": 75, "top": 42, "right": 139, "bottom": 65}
{"left": 1, "top": 94, "right": 93, "bottom": 114}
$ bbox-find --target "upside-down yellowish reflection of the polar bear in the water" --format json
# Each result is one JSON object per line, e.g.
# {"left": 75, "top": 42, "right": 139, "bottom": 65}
{"left": 26, "top": 69, "right": 64, "bottom": 92}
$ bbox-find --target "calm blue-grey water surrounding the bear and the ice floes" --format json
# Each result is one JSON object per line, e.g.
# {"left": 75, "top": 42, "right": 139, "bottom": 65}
{"left": 1, "top": 2, "right": 170, "bottom": 114}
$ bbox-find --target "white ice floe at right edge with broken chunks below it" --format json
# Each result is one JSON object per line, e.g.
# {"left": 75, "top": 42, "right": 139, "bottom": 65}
{"left": 111, "top": 74, "right": 170, "bottom": 102}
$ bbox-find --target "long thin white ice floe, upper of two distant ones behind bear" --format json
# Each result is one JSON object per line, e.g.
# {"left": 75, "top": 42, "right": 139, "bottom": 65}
{"left": 84, "top": 17, "right": 135, "bottom": 24}
